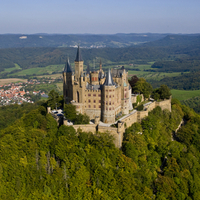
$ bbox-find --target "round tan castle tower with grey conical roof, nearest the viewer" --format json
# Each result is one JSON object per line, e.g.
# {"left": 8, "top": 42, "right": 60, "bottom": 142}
{"left": 101, "top": 69, "right": 116, "bottom": 123}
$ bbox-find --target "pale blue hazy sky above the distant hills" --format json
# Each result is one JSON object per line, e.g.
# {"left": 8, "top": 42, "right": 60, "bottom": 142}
{"left": 0, "top": 0, "right": 200, "bottom": 34}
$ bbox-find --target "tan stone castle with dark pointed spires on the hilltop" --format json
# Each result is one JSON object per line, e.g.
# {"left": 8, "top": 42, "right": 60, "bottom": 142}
{"left": 63, "top": 47, "right": 133, "bottom": 123}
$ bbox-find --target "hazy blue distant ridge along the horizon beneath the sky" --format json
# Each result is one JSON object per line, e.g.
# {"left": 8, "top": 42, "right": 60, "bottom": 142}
{"left": 0, "top": 33, "right": 166, "bottom": 48}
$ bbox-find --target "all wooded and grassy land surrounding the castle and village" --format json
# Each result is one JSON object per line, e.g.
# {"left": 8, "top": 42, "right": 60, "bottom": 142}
{"left": 0, "top": 34, "right": 200, "bottom": 200}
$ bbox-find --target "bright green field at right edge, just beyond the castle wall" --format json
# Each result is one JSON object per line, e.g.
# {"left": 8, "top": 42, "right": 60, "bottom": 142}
{"left": 171, "top": 90, "right": 200, "bottom": 101}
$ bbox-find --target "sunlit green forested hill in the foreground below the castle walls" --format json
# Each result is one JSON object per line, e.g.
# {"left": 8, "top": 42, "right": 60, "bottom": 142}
{"left": 0, "top": 97, "right": 200, "bottom": 200}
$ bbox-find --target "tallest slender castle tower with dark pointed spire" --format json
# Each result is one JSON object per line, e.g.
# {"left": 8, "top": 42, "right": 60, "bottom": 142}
{"left": 74, "top": 46, "right": 83, "bottom": 81}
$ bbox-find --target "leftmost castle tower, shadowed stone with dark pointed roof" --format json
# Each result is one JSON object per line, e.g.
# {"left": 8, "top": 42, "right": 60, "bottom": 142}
{"left": 63, "top": 58, "right": 73, "bottom": 103}
